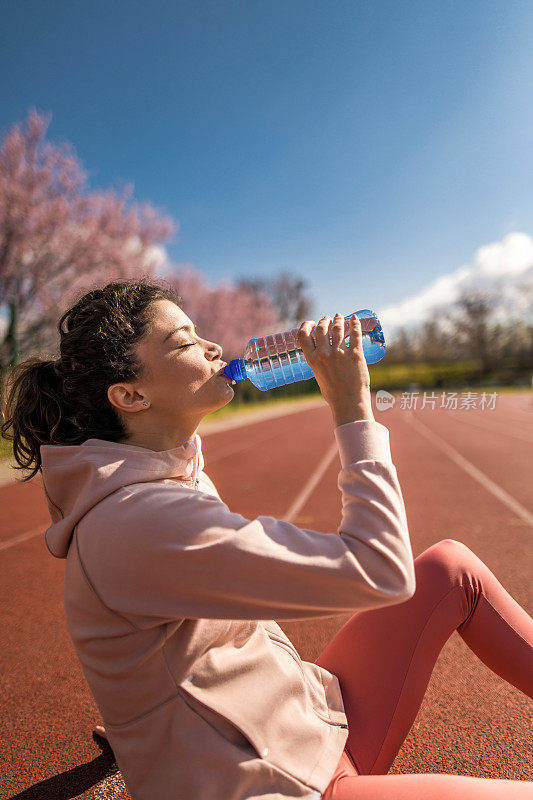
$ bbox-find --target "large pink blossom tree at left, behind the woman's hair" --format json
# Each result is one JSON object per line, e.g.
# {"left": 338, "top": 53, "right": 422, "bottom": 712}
{"left": 0, "top": 110, "right": 176, "bottom": 367}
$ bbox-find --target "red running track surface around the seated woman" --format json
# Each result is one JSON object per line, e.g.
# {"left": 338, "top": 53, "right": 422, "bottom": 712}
{"left": 0, "top": 393, "right": 533, "bottom": 800}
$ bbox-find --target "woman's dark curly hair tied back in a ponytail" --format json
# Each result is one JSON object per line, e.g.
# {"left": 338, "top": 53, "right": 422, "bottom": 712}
{"left": 0, "top": 279, "right": 182, "bottom": 481}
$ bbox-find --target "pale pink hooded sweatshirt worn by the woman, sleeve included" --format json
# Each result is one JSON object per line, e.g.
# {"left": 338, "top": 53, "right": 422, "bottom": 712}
{"left": 41, "top": 421, "right": 414, "bottom": 800}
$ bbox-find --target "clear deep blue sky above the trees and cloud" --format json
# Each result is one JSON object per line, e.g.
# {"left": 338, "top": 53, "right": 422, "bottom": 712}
{"left": 0, "top": 0, "right": 533, "bottom": 332}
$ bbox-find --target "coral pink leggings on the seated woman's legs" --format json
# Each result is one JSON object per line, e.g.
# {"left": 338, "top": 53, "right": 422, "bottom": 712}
{"left": 316, "top": 539, "right": 533, "bottom": 800}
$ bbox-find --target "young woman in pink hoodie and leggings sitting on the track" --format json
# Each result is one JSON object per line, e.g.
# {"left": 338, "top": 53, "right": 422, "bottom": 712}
{"left": 3, "top": 281, "right": 533, "bottom": 800}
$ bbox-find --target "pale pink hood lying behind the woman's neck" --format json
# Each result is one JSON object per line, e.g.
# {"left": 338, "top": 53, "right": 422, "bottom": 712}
{"left": 40, "top": 433, "right": 204, "bottom": 558}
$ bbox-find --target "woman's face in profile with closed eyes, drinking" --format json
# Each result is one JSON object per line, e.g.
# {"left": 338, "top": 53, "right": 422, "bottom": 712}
{"left": 125, "top": 300, "right": 234, "bottom": 427}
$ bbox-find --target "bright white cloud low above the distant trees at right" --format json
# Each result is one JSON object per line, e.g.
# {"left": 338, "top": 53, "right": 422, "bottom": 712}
{"left": 378, "top": 232, "right": 533, "bottom": 332}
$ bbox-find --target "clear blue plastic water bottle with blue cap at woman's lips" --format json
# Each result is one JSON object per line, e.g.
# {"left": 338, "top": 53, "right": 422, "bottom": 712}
{"left": 224, "top": 308, "right": 385, "bottom": 392}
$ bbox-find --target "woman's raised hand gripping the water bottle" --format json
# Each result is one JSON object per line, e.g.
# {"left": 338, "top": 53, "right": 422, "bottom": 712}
{"left": 298, "top": 314, "right": 374, "bottom": 426}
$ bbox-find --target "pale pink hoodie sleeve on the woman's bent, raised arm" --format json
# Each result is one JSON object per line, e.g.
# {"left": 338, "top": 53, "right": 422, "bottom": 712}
{"left": 77, "top": 420, "right": 415, "bottom": 628}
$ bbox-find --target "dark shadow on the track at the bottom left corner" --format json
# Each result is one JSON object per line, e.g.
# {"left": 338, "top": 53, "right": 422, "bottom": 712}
{"left": 5, "top": 733, "right": 118, "bottom": 800}
